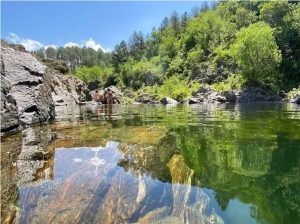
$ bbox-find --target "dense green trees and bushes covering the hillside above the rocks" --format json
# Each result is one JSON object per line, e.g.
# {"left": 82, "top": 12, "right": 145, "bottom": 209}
{"left": 38, "top": 0, "right": 300, "bottom": 98}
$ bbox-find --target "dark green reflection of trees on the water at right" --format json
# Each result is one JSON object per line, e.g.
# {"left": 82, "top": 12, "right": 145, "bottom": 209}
{"left": 161, "top": 125, "right": 300, "bottom": 223}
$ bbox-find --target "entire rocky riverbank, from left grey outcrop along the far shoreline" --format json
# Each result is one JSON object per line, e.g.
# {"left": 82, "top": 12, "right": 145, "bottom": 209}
{"left": 1, "top": 42, "right": 300, "bottom": 135}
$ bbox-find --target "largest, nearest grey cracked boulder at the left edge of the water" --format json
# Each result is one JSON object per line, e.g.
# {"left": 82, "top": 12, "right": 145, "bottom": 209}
{"left": 1, "top": 42, "right": 54, "bottom": 132}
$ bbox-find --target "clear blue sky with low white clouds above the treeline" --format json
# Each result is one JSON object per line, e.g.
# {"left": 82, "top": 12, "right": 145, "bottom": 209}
{"left": 1, "top": 1, "right": 201, "bottom": 49}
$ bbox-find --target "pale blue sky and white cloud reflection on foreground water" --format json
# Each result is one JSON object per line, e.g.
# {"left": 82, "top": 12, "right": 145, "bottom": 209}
{"left": 20, "top": 142, "right": 262, "bottom": 224}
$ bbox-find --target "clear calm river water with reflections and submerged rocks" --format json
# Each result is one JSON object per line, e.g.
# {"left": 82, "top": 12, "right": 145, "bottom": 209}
{"left": 1, "top": 104, "right": 300, "bottom": 224}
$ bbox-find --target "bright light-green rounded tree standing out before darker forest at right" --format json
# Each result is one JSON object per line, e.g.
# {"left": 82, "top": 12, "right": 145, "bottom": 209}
{"left": 230, "top": 22, "right": 281, "bottom": 85}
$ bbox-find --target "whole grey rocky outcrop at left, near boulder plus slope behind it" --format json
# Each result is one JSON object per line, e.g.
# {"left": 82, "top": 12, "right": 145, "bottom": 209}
{"left": 0, "top": 42, "right": 89, "bottom": 133}
